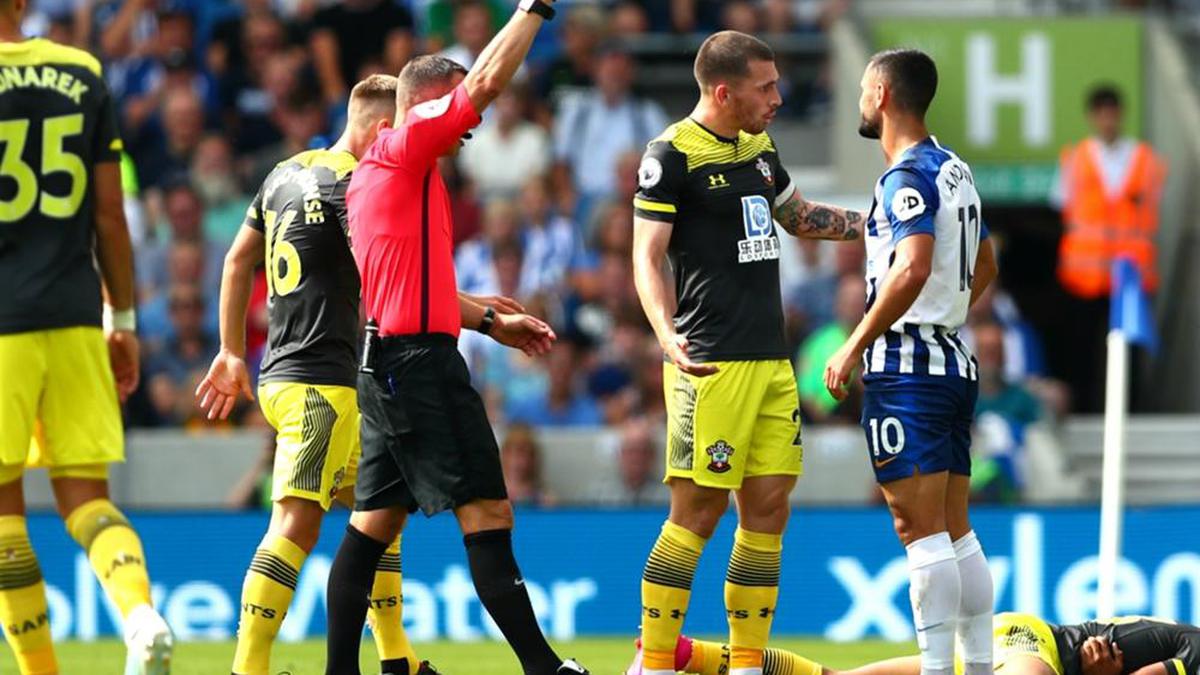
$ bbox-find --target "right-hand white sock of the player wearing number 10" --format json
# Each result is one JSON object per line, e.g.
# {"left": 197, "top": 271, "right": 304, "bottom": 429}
{"left": 954, "top": 530, "right": 992, "bottom": 675}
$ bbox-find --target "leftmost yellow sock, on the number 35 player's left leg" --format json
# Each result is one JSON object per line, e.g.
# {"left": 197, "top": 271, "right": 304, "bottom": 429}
{"left": 0, "top": 515, "right": 59, "bottom": 675}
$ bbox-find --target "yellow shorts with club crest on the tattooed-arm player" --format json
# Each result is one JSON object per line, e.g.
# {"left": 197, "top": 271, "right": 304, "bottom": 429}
{"left": 662, "top": 360, "right": 804, "bottom": 490}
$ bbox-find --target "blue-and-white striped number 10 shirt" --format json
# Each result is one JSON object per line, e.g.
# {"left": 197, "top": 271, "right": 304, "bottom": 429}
{"left": 863, "top": 137, "right": 988, "bottom": 382}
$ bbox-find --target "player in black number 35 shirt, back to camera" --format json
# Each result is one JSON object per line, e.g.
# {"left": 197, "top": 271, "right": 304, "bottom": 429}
{"left": 0, "top": 0, "right": 172, "bottom": 675}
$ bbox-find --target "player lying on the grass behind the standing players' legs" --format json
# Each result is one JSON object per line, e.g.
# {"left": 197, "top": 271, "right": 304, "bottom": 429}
{"left": 676, "top": 613, "right": 1200, "bottom": 675}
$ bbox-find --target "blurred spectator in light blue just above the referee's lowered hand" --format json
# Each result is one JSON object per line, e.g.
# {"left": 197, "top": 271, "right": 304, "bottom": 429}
{"left": 518, "top": 175, "right": 578, "bottom": 298}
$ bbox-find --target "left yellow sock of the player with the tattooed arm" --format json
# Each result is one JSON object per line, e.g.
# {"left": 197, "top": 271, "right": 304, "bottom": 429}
{"left": 642, "top": 521, "right": 707, "bottom": 675}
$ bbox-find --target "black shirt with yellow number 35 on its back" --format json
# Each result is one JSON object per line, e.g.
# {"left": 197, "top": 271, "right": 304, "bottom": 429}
{"left": 0, "top": 40, "right": 121, "bottom": 334}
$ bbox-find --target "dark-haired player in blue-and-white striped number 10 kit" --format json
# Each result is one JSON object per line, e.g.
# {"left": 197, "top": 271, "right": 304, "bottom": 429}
{"left": 824, "top": 49, "right": 997, "bottom": 675}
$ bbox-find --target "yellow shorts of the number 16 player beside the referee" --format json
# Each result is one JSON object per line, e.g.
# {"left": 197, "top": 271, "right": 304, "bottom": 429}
{"left": 258, "top": 382, "right": 361, "bottom": 509}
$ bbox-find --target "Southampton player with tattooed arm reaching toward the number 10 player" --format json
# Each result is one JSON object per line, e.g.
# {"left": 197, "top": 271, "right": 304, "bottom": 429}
{"left": 628, "top": 31, "right": 863, "bottom": 675}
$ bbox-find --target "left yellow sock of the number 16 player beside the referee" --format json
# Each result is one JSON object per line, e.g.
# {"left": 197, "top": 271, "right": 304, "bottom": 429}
{"left": 233, "top": 532, "right": 308, "bottom": 675}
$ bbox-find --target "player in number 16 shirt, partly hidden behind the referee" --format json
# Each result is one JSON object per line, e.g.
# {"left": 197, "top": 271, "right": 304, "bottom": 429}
{"left": 190, "top": 74, "right": 432, "bottom": 675}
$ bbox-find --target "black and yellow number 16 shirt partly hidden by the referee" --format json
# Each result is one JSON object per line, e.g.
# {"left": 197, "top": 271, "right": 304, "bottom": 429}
{"left": 245, "top": 150, "right": 359, "bottom": 387}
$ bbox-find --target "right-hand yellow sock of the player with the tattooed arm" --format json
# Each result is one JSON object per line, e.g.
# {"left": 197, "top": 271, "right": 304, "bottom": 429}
{"left": 725, "top": 527, "right": 784, "bottom": 675}
